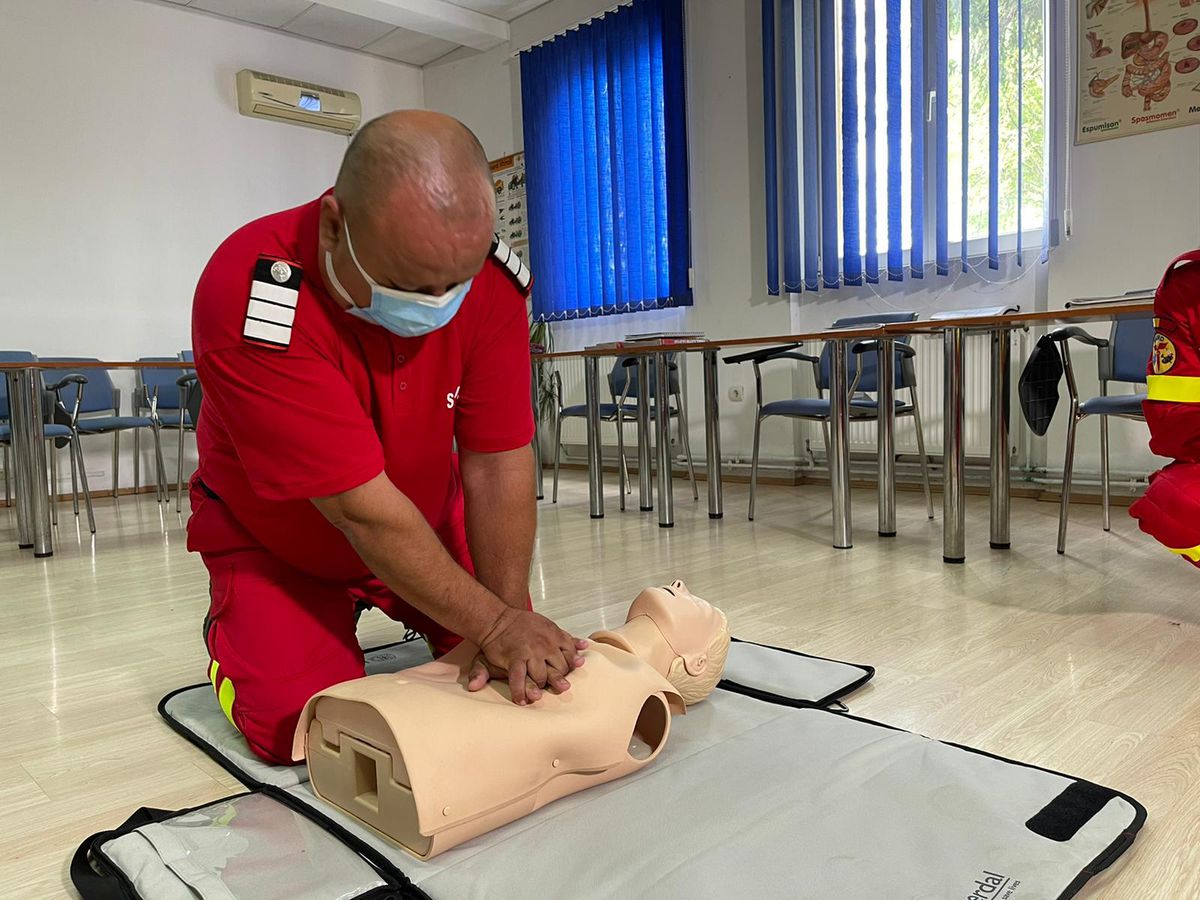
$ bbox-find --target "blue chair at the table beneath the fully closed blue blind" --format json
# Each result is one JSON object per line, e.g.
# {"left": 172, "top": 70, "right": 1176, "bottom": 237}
{"left": 550, "top": 353, "right": 700, "bottom": 510}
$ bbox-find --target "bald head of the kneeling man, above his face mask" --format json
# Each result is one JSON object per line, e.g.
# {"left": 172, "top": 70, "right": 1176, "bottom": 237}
{"left": 320, "top": 109, "right": 496, "bottom": 305}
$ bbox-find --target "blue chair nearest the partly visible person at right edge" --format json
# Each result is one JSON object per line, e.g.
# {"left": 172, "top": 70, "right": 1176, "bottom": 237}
{"left": 1049, "top": 316, "right": 1154, "bottom": 553}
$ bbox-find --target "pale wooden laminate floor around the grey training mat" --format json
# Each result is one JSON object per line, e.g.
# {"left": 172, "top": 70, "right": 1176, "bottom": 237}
{"left": 0, "top": 473, "right": 1200, "bottom": 900}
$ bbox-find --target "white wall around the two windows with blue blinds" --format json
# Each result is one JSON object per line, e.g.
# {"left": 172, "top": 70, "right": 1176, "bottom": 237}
{"left": 425, "top": 0, "right": 1200, "bottom": 476}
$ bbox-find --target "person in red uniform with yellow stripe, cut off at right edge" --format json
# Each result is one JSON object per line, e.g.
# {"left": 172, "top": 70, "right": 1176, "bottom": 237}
{"left": 1129, "top": 250, "right": 1200, "bottom": 566}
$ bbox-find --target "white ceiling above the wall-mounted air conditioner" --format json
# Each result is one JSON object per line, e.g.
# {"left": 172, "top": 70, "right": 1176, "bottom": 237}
{"left": 154, "top": 0, "right": 548, "bottom": 66}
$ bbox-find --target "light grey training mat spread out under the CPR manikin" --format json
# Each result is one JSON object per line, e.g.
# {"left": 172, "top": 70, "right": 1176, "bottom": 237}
{"left": 85, "top": 642, "right": 1145, "bottom": 900}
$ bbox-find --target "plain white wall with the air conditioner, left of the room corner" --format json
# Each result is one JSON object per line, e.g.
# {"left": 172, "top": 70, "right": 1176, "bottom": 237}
{"left": 0, "top": 0, "right": 424, "bottom": 494}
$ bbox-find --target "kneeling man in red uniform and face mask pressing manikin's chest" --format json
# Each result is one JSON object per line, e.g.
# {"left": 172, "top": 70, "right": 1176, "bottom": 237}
{"left": 188, "top": 110, "right": 586, "bottom": 763}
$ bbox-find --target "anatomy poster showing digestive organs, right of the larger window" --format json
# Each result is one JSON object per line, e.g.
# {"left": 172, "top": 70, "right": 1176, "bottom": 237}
{"left": 1075, "top": 0, "right": 1200, "bottom": 144}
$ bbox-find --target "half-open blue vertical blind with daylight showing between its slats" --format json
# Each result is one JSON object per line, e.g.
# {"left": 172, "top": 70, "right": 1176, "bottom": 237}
{"left": 762, "top": 0, "right": 1051, "bottom": 294}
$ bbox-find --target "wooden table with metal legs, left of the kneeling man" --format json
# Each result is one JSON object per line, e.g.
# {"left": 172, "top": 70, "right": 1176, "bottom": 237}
{"left": 0, "top": 360, "right": 193, "bottom": 558}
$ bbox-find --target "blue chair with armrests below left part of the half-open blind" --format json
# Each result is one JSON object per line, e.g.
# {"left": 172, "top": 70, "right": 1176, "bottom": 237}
{"left": 725, "top": 312, "right": 934, "bottom": 521}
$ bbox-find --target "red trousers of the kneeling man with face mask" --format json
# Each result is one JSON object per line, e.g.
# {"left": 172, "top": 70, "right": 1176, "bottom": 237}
{"left": 200, "top": 549, "right": 472, "bottom": 766}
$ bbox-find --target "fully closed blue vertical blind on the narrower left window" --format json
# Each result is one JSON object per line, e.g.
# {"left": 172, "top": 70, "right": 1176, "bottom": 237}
{"left": 521, "top": 0, "right": 691, "bottom": 322}
